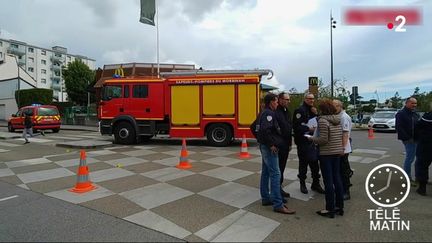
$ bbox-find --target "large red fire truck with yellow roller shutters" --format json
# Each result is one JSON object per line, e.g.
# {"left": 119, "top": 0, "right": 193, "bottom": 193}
{"left": 98, "top": 70, "right": 272, "bottom": 146}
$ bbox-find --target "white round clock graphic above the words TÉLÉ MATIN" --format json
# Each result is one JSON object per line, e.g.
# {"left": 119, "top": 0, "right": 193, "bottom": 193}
{"left": 365, "top": 164, "right": 411, "bottom": 207}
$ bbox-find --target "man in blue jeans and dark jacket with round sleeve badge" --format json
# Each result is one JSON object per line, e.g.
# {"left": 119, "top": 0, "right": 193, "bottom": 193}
{"left": 257, "top": 93, "right": 295, "bottom": 214}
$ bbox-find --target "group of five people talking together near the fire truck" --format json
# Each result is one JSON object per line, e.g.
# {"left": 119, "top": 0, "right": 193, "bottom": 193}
{"left": 255, "top": 92, "right": 352, "bottom": 218}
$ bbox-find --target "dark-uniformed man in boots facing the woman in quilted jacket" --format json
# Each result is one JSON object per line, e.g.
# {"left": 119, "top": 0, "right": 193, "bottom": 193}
{"left": 293, "top": 93, "right": 324, "bottom": 194}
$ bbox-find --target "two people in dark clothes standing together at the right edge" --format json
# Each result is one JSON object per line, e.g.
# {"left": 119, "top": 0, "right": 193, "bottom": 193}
{"left": 396, "top": 97, "right": 432, "bottom": 196}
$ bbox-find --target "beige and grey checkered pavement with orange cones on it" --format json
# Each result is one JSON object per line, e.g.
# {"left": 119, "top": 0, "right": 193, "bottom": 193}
{"left": 0, "top": 134, "right": 387, "bottom": 241}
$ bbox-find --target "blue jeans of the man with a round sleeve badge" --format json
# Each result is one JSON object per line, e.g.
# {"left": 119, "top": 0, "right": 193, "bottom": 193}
{"left": 260, "top": 144, "right": 283, "bottom": 209}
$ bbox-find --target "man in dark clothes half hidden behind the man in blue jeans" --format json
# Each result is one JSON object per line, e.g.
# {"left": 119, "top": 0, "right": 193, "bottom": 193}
{"left": 275, "top": 92, "right": 292, "bottom": 197}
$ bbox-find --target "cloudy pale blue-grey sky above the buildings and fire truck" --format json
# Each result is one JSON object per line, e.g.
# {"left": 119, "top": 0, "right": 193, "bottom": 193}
{"left": 0, "top": 0, "right": 432, "bottom": 102}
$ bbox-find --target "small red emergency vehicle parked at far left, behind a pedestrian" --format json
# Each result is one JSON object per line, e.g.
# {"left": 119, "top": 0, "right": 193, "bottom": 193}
{"left": 8, "top": 104, "right": 61, "bottom": 133}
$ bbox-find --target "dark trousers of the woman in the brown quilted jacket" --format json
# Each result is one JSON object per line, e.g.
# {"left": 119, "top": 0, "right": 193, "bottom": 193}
{"left": 319, "top": 155, "right": 343, "bottom": 212}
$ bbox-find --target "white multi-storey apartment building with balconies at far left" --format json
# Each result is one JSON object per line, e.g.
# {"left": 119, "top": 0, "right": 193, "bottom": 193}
{"left": 0, "top": 38, "right": 96, "bottom": 101}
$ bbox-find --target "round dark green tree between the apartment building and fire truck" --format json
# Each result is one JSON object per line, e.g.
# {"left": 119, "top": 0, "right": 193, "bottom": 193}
{"left": 62, "top": 60, "right": 95, "bottom": 105}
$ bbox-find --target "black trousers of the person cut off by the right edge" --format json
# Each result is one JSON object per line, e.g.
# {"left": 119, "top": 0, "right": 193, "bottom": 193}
{"left": 415, "top": 143, "right": 432, "bottom": 182}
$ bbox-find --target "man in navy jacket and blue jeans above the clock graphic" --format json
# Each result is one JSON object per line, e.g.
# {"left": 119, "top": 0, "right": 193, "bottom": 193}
{"left": 396, "top": 97, "right": 419, "bottom": 182}
